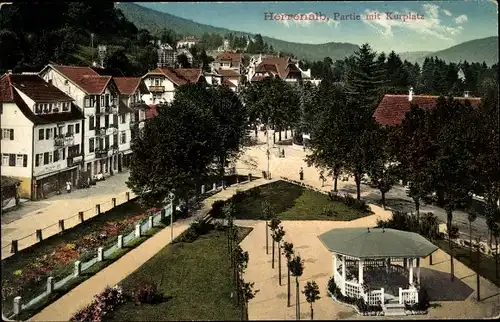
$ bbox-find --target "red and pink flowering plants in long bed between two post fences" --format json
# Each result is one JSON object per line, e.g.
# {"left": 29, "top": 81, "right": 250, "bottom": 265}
{"left": 2, "top": 201, "right": 159, "bottom": 314}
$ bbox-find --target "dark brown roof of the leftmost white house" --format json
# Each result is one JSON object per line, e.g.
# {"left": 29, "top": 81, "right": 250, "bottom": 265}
{"left": 7, "top": 74, "right": 73, "bottom": 103}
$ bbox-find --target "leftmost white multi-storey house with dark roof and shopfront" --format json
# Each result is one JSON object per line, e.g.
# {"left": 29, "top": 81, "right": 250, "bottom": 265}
{"left": 0, "top": 74, "right": 84, "bottom": 200}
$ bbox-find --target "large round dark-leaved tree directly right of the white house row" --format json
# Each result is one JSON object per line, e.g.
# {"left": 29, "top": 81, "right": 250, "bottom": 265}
{"left": 127, "top": 100, "right": 217, "bottom": 206}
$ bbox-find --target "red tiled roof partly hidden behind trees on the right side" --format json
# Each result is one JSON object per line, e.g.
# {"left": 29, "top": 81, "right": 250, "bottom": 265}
{"left": 373, "top": 95, "right": 481, "bottom": 126}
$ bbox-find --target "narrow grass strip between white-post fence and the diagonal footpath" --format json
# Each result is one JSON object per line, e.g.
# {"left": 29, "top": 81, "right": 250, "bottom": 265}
{"left": 13, "top": 224, "right": 166, "bottom": 321}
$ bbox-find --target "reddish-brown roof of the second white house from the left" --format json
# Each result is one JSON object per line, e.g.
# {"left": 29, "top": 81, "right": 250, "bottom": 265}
{"left": 42, "top": 64, "right": 112, "bottom": 95}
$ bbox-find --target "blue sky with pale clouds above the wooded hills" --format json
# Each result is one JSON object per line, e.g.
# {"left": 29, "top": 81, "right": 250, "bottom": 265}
{"left": 138, "top": 0, "right": 498, "bottom": 52}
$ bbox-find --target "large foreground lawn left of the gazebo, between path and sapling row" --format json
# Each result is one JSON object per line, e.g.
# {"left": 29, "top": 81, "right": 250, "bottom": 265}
{"left": 110, "top": 227, "right": 252, "bottom": 321}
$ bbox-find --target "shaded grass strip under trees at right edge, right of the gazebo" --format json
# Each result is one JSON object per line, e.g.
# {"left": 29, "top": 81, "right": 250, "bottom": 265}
{"left": 433, "top": 240, "right": 500, "bottom": 287}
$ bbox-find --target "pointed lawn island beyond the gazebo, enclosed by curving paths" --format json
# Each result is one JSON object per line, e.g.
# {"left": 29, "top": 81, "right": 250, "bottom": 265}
{"left": 223, "top": 181, "right": 368, "bottom": 221}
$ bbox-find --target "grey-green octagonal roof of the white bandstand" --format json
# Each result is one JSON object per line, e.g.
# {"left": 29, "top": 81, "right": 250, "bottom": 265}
{"left": 318, "top": 228, "right": 438, "bottom": 259}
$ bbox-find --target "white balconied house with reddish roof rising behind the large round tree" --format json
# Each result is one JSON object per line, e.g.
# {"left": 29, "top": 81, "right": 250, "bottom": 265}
{"left": 142, "top": 67, "right": 205, "bottom": 105}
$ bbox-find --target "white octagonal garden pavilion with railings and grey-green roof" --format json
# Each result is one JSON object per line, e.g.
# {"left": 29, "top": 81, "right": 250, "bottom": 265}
{"left": 318, "top": 228, "right": 438, "bottom": 306}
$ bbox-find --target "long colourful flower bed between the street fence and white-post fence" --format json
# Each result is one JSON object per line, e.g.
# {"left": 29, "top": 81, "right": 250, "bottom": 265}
{"left": 2, "top": 201, "right": 159, "bottom": 312}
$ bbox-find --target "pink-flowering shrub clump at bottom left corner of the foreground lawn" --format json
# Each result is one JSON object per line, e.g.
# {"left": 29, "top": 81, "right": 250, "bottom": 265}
{"left": 70, "top": 286, "right": 126, "bottom": 322}
